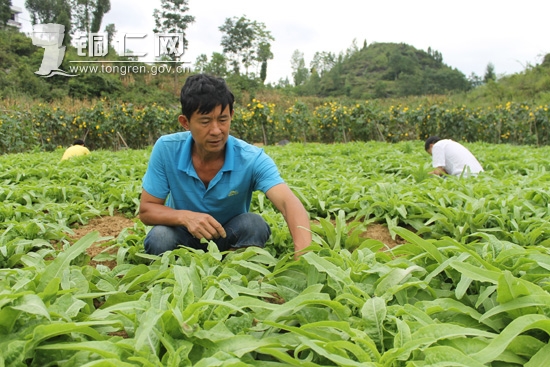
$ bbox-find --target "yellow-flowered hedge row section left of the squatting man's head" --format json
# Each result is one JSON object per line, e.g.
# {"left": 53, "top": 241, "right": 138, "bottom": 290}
{"left": 0, "top": 100, "right": 179, "bottom": 153}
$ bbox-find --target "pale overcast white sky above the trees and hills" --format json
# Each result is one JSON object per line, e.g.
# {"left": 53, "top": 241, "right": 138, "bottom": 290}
{"left": 12, "top": 0, "right": 550, "bottom": 83}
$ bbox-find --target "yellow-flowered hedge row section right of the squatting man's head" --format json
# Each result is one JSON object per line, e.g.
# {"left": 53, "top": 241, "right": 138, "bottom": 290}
{"left": 233, "top": 100, "right": 550, "bottom": 145}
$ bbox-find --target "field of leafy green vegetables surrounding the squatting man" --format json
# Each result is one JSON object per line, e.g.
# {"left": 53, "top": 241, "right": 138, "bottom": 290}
{"left": 0, "top": 140, "right": 550, "bottom": 367}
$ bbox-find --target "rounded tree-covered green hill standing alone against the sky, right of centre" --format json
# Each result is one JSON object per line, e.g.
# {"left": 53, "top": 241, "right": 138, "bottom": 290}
{"left": 301, "top": 43, "right": 470, "bottom": 99}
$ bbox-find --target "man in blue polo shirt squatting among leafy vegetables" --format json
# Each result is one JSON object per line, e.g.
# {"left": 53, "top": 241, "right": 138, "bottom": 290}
{"left": 139, "top": 74, "right": 311, "bottom": 255}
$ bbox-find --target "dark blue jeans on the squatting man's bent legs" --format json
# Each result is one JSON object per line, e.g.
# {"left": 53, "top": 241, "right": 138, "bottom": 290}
{"left": 143, "top": 213, "right": 271, "bottom": 255}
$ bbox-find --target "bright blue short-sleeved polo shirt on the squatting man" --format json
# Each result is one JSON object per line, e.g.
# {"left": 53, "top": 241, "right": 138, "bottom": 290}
{"left": 143, "top": 131, "right": 284, "bottom": 225}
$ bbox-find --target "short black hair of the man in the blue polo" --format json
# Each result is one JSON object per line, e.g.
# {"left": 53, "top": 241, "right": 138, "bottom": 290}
{"left": 180, "top": 74, "right": 235, "bottom": 120}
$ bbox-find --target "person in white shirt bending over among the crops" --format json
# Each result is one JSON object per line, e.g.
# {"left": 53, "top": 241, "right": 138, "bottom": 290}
{"left": 424, "top": 136, "right": 483, "bottom": 177}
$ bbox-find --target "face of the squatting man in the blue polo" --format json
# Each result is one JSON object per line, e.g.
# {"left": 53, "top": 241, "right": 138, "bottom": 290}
{"left": 179, "top": 105, "right": 233, "bottom": 153}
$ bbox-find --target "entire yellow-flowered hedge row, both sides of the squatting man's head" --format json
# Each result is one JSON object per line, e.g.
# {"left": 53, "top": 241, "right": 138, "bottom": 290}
{"left": 0, "top": 99, "right": 550, "bottom": 153}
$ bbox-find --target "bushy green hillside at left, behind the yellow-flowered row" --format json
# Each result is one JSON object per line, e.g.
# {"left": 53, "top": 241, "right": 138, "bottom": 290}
{"left": 0, "top": 28, "right": 183, "bottom": 104}
